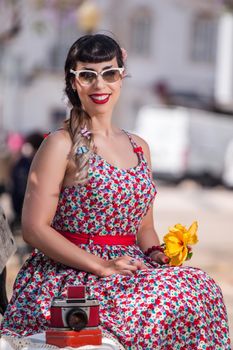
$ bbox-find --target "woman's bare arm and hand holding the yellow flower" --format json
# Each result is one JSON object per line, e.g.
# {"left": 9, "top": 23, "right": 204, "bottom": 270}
{"left": 133, "top": 135, "right": 169, "bottom": 263}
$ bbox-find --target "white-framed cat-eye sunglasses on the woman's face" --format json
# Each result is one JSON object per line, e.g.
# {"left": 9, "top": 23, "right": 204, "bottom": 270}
{"left": 70, "top": 67, "right": 125, "bottom": 85}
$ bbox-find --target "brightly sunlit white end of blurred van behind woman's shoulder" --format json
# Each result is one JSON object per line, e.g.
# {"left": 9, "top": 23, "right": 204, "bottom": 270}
{"left": 133, "top": 106, "right": 189, "bottom": 182}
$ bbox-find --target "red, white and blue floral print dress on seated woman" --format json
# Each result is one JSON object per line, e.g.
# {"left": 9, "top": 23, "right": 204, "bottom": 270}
{"left": 1, "top": 133, "right": 230, "bottom": 350}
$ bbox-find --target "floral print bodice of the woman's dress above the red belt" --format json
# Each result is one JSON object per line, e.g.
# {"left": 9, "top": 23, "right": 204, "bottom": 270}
{"left": 52, "top": 134, "right": 156, "bottom": 235}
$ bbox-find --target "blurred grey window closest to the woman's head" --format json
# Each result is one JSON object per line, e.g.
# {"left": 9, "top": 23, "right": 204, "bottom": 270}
{"left": 130, "top": 7, "right": 152, "bottom": 56}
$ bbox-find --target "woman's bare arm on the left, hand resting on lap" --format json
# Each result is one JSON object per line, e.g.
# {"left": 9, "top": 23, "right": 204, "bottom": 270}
{"left": 22, "top": 130, "right": 146, "bottom": 277}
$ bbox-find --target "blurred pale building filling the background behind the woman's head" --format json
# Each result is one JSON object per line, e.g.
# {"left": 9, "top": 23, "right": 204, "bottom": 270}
{"left": 0, "top": 0, "right": 233, "bottom": 133}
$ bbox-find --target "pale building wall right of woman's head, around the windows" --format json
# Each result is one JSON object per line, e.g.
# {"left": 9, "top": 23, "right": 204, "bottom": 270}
{"left": 103, "top": 0, "right": 218, "bottom": 128}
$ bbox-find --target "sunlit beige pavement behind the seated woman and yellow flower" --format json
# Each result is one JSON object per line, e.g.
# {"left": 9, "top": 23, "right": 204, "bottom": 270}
{"left": 0, "top": 182, "right": 233, "bottom": 339}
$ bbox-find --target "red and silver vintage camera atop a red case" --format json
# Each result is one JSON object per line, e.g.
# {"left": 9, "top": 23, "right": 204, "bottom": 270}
{"left": 50, "top": 286, "right": 100, "bottom": 331}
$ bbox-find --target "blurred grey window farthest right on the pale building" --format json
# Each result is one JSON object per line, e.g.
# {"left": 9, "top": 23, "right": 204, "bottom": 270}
{"left": 191, "top": 14, "right": 217, "bottom": 63}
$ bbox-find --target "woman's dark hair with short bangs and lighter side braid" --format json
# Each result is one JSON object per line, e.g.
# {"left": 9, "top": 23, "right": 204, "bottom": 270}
{"left": 64, "top": 34, "right": 124, "bottom": 183}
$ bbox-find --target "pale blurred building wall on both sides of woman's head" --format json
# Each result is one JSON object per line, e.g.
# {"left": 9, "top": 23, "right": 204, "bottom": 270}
{"left": 0, "top": 0, "right": 222, "bottom": 130}
